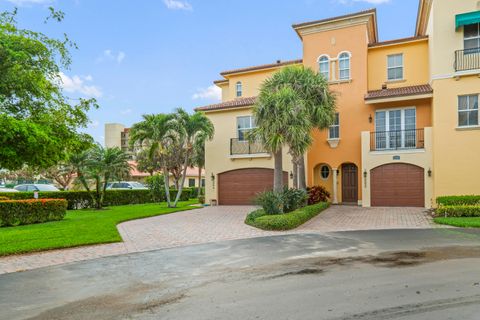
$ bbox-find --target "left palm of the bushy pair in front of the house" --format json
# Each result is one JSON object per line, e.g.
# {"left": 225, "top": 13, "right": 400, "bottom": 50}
{"left": 249, "top": 85, "right": 311, "bottom": 191}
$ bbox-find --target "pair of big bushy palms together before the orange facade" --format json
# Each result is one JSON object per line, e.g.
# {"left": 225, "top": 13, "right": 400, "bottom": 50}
{"left": 252, "top": 66, "right": 336, "bottom": 190}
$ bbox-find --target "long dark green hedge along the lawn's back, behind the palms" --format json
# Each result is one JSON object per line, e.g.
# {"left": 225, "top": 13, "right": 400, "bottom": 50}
{"left": 0, "top": 189, "right": 192, "bottom": 210}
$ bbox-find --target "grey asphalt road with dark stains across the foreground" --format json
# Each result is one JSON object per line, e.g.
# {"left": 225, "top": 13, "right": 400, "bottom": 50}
{"left": 0, "top": 229, "right": 480, "bottom": 320}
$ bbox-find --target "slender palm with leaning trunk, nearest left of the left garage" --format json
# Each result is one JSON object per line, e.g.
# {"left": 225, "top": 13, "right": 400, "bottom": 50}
{"left": 173, "top": 108, "right": 214, "bottom": 207}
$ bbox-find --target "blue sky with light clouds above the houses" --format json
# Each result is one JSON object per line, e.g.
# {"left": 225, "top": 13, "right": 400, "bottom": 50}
{"left": 0, "top": 0, "right": 418, "bottom": 143}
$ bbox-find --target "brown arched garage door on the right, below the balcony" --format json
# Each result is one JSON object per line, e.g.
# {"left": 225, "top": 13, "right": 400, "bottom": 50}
{"left": 371, "top": 163, "right": 425, "bottom": 207}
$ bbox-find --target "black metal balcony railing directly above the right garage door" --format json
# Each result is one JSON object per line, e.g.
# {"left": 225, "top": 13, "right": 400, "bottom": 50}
{"left": 370, "top": 129, "right": 425, "bottom": 151}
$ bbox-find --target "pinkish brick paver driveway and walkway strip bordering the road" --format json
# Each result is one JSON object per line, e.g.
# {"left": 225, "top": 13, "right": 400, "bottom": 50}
{"left": 0, "top": 206, "right": 432, "bottom": 274}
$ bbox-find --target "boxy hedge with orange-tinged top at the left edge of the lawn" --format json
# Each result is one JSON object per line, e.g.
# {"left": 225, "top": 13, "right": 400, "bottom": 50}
{"left": 0, "top": 199, "right": 67, "bottom": 227}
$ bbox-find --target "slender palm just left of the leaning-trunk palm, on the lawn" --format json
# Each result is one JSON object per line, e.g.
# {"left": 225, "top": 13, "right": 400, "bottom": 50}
{"left": 130, "top": 113, "right": 178, "bottom": 207}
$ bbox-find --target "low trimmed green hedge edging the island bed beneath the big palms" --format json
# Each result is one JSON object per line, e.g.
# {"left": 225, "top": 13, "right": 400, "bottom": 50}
{"left": 245, "top": 202, "right": 330, "bottom": 231}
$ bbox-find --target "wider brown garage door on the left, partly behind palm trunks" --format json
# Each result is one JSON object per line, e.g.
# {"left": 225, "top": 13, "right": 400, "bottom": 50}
{"left": 218, "top": 168, "right": 288, "bottom": 205}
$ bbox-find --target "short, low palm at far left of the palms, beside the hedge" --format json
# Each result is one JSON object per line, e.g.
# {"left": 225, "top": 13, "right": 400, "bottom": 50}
{"left": 71, "top": 145, "right": 130, "bottom": 209}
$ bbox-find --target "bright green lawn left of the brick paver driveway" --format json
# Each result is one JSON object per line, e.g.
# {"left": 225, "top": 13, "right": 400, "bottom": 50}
{"left": 0, "top": 200, "right": 197, "bottom": 256}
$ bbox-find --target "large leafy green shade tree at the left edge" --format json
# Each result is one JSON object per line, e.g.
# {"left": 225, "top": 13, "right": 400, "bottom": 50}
{"left": 0, "top": 9, "right": 96, "bottom": 170}
